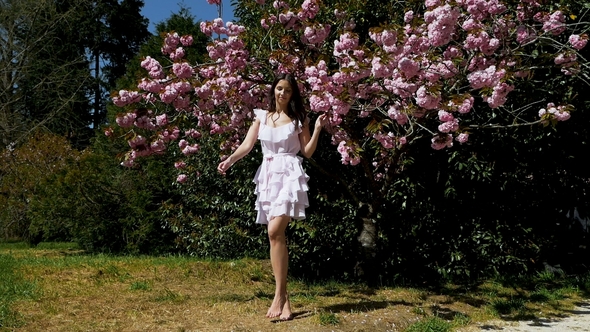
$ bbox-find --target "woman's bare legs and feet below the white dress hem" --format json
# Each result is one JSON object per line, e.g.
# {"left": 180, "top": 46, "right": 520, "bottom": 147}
{"left": 266, "top": 215, "right": 292, "bottom": 319}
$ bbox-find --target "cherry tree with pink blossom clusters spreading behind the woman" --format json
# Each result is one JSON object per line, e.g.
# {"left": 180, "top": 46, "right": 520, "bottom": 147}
{"left": 105, "top": 0, "right": 590, "bottom": 272}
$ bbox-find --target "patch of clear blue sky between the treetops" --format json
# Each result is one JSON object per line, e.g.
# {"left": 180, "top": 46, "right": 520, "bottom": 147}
{"left": 141, "top": 0, "right": 235, "bottom": 33}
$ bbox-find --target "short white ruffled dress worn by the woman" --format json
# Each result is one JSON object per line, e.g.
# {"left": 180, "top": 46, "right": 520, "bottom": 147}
{"left": 254, "top": 109, "right": 309, "bottom": 224}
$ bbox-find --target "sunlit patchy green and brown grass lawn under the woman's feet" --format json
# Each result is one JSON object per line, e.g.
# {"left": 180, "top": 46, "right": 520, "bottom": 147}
{"left": 0, "top": 243, "right": 590, "bottom": 332}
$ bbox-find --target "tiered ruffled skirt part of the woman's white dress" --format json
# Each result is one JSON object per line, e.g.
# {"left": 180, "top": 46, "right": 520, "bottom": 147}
{"left": 254, "top": 153, "right": 309, "bottom": 224}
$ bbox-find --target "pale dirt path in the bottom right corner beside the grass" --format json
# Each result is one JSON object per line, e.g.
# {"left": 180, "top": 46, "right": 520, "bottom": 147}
{"left": 470, "top": 301, "right": 590, "bottom": 332}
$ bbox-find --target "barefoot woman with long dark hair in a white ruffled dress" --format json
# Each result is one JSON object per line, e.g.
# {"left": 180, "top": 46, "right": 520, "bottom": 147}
{"left": 217, "top": 74, "right": 327, "bottom": 320}
